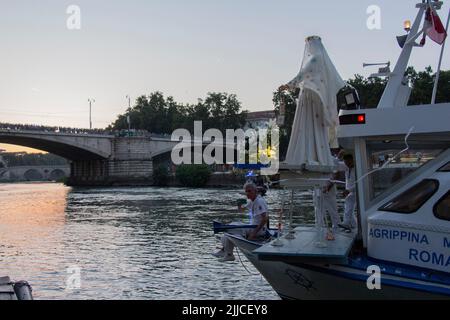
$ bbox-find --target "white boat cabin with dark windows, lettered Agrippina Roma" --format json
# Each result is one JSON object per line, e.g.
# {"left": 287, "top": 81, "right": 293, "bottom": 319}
{"left": 338, "top": 103, "right": 450, "bottom": 272}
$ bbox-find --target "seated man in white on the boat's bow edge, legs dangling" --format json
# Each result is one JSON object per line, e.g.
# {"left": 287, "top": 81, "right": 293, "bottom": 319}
{"left": 214, "top": 182, "right": 269, "bottom": 262}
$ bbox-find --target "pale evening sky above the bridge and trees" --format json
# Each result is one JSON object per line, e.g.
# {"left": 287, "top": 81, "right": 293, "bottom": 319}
{"left": 0, "top": 0, "right": 450, "bottom": 152}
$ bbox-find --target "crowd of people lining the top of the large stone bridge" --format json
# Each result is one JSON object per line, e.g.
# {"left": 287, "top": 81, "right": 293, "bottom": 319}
{"left": 0, "top": 122, "right": 171, "bottom": 139}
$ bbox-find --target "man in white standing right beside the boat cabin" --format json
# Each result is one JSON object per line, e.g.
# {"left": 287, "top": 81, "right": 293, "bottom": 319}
{"left": 339, "top": 154, "right": 357, "bottom": 231}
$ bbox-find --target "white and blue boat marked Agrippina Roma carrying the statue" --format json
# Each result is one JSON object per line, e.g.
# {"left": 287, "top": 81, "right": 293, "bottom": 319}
{"left": 227, "top": 1, "right": 450, "bottom": 300}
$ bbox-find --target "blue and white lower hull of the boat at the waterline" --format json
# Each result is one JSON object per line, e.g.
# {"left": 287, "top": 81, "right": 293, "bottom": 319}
{"left": 230, "top": 236, "right": 450, "bottom": 300}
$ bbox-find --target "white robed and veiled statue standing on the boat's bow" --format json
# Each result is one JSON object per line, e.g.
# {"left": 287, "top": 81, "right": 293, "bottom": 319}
{"left": 285, "top": 36, "right": 345, "bottom": 166}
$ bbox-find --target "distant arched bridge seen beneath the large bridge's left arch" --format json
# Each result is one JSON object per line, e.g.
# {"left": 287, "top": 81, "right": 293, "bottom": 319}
{"left": 0, "top": 165, "right": 70, "bottom": 182}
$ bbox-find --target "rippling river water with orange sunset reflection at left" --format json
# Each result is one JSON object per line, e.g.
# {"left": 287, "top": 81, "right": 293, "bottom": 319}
{"left": 0, "top": 183, "right": 320, "bottom": 300}
